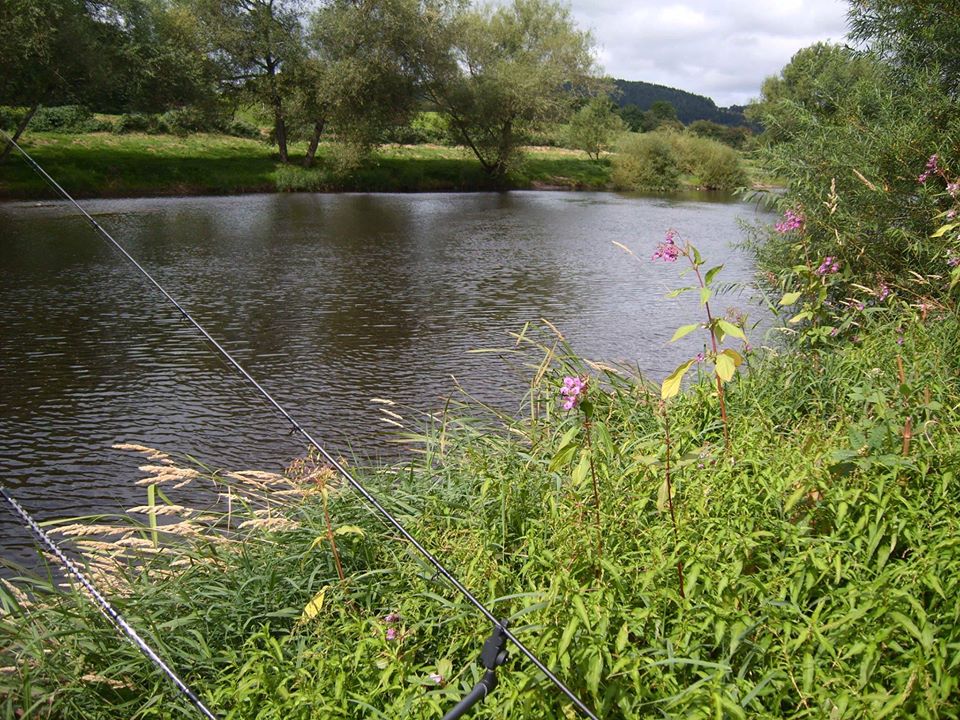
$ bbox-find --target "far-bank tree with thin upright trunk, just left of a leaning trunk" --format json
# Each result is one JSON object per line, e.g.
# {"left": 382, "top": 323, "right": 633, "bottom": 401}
{"left": 192, "top": 0, "right": 304, "bottom": 163}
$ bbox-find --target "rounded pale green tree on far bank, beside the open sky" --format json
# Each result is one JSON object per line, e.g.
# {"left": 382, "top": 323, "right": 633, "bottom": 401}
{"left": 417, "top": 0, "right": 597, "bottom": 182}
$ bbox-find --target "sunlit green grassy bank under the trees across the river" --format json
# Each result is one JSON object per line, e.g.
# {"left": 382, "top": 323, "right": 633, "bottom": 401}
{"left": 0, "top": 133, "right": 610, "bottom": 199}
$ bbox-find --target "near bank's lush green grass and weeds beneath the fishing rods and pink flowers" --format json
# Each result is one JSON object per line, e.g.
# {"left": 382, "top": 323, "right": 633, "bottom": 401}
{"left": 0, "top": 303, "right": 960, "bottom": 720}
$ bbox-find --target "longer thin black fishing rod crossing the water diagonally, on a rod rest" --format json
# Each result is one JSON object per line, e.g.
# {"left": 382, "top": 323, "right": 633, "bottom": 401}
{"left": 0, "top": 130, "right": 599, "bottom": 720}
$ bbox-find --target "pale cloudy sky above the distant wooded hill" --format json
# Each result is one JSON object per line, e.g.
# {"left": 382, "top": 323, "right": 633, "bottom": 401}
{"left": 570, "top": 0, "right": 848, "bottom": 107}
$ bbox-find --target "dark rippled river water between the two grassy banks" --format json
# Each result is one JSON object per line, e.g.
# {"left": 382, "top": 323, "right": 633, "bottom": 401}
{"left": 0, "top": 192, "right": 756, "bottom": 559}
